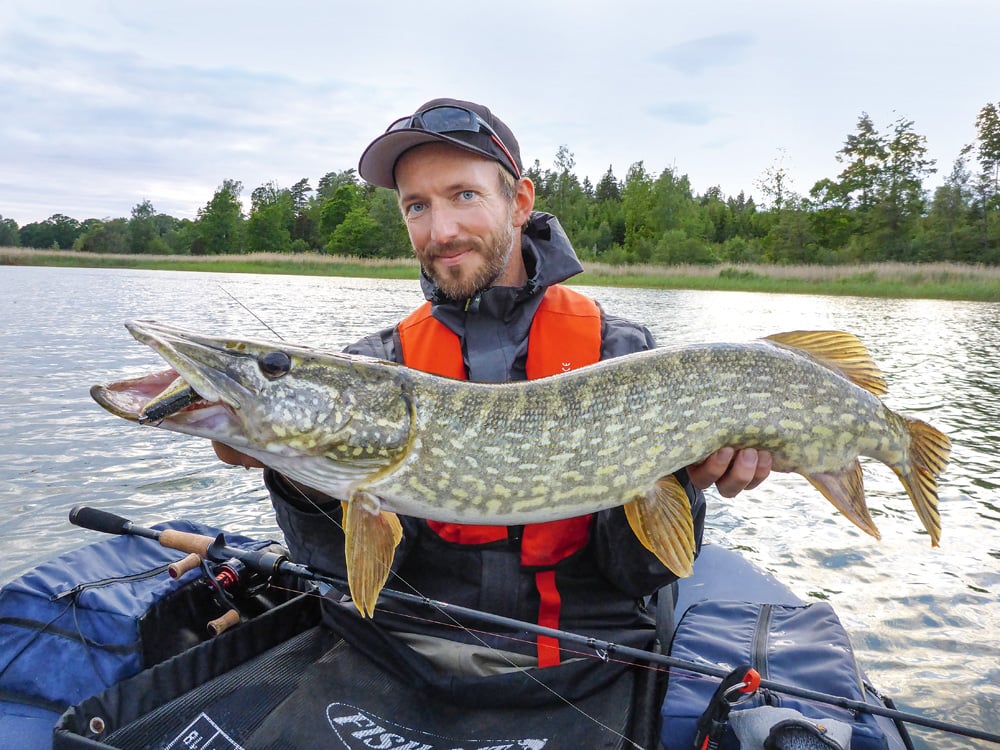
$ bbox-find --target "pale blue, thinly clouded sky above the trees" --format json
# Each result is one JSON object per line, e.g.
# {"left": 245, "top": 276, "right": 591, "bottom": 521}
{"left": 0, "top": 0, "right": 1000, "bottom": 226}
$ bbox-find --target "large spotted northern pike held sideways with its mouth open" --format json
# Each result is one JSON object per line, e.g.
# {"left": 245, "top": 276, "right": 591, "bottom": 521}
{"left": 91, "top": 321, "right": 950, "bottom": 614}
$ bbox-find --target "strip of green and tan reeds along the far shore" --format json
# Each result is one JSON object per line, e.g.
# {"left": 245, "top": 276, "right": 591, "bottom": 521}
{"left": 0, "top": 248, "right": 1000, "bottom": 302}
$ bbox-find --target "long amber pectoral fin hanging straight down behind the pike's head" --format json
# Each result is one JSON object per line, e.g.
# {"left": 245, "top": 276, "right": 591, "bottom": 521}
{"left": 343, "top": 492, "right": 403, "bottom": 617}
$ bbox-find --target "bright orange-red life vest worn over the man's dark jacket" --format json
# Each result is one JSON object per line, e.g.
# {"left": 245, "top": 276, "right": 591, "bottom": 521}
{"left": 398, "top": 285, "right": 601, "bottom": 667}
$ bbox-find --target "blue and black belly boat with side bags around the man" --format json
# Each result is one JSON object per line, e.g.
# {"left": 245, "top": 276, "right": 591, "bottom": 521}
{"left": 0, "top": 521, "right": 911, "bottom": 750}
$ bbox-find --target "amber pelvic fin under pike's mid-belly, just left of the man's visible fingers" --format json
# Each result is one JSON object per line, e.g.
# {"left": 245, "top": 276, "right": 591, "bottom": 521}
{"left": 625, "top": 474, "right": 695, "bottom": 578}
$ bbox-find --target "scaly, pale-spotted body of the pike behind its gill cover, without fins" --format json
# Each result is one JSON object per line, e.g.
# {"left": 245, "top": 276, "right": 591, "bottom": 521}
{"left": 376, "top": 343, "right": 909, "bottom": 523}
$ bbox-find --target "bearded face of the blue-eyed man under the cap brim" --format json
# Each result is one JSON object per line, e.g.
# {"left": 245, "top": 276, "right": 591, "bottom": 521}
{"left": 396, "top": 143, "right": 520, "bottom": 300}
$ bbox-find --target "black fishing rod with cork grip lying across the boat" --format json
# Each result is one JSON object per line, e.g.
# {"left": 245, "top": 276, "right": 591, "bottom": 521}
{"left": 69, "top": 505, "right": 1000, "bottom": 744}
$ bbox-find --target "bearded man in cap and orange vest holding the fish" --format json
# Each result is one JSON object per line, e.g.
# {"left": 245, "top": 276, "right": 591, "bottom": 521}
{"left": 216, "top": 99, "right": 771, "bottom": 671}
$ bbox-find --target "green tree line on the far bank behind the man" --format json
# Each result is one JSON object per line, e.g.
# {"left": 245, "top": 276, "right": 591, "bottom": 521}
{"left": 0, "top": 103, "right": 1000, "bottom": 265}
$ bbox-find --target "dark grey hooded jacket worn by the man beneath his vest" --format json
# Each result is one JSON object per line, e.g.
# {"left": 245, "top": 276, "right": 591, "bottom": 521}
{"left": 265, "top": 213, "right": 705, "bottom": 653}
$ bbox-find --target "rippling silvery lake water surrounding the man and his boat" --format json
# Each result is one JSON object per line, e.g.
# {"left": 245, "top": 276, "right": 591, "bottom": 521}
{"left": 0, "top": 267, "right": 1000, "bottom": 750}
